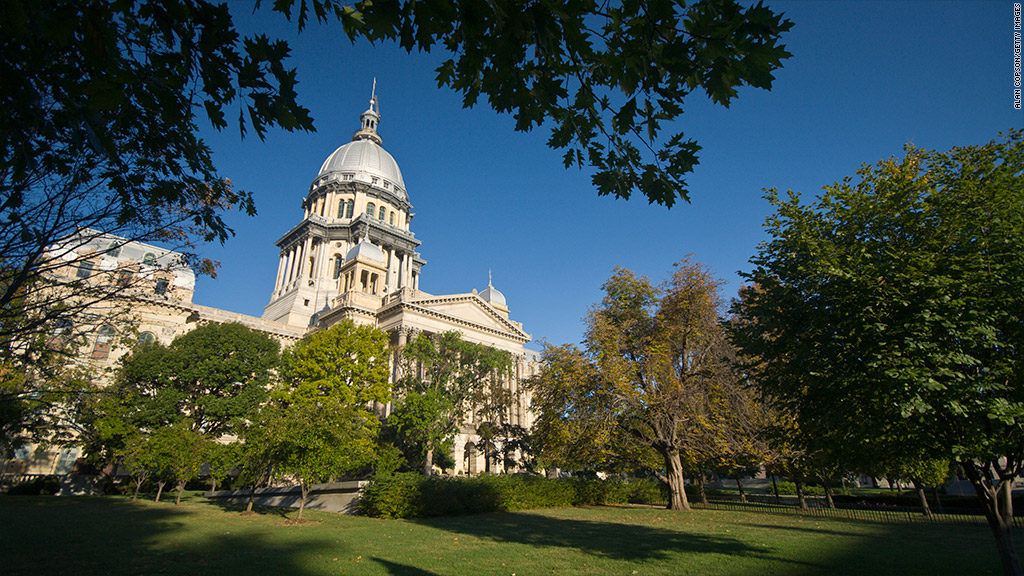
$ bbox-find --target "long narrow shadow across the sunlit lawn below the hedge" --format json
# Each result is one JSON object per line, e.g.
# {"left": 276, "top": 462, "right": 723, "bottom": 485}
{"left": 419, "top": 509, "right": 790, "bottom": 562}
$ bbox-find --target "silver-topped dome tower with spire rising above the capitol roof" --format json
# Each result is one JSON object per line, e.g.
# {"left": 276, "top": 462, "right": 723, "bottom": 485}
{"left": 263, "top": 87, "right": 426, "bottom": 327}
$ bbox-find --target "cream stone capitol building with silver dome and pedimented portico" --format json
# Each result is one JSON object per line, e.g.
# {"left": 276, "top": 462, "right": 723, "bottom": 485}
{"left": 15, "top": 93, "right": 540, "bottom": 474}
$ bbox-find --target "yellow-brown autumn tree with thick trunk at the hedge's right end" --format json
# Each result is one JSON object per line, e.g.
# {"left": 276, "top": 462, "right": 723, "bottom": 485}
{"left": 531, "top": 260, "right": 749, "bottom": 509}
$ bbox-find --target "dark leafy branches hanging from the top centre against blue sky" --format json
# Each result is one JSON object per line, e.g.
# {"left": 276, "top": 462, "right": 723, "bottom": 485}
{"left": 264, "top": 0, "right": 793, "bottom": 207}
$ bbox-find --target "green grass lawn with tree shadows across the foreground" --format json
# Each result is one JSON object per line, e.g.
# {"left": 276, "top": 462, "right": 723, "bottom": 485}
{"left": 0, "top": 496, "right": 1024, "bottom": 576}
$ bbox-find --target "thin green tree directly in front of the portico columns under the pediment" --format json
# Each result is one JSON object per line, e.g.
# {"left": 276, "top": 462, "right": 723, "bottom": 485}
{"left": 395, "top": 331, "right": 512, "bottom": 476}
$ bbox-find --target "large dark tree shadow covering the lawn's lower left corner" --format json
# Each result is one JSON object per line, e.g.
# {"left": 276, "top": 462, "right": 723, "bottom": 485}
{"left": 0, "top": 497, "right": 344, "bottom": 576}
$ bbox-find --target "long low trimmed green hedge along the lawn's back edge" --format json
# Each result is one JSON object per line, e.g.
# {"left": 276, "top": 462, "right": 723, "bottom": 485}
{"left": 359, "top": 472, "right": 667, "bottom": 518}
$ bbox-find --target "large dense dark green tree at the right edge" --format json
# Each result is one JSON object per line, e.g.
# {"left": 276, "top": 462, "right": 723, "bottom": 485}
{"left": 736, "top": 131, "right": 1024, "bottom": 574}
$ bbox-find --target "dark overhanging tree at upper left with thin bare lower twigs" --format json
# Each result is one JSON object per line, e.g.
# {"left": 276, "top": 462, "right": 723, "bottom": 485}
{"left": 0, "top": 0, "right": 312, "bottom": 373}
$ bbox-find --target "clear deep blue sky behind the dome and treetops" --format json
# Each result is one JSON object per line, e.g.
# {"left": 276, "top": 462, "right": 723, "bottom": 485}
{"left": 195, "top": 0, "right": 1024, "bottom": 347}
